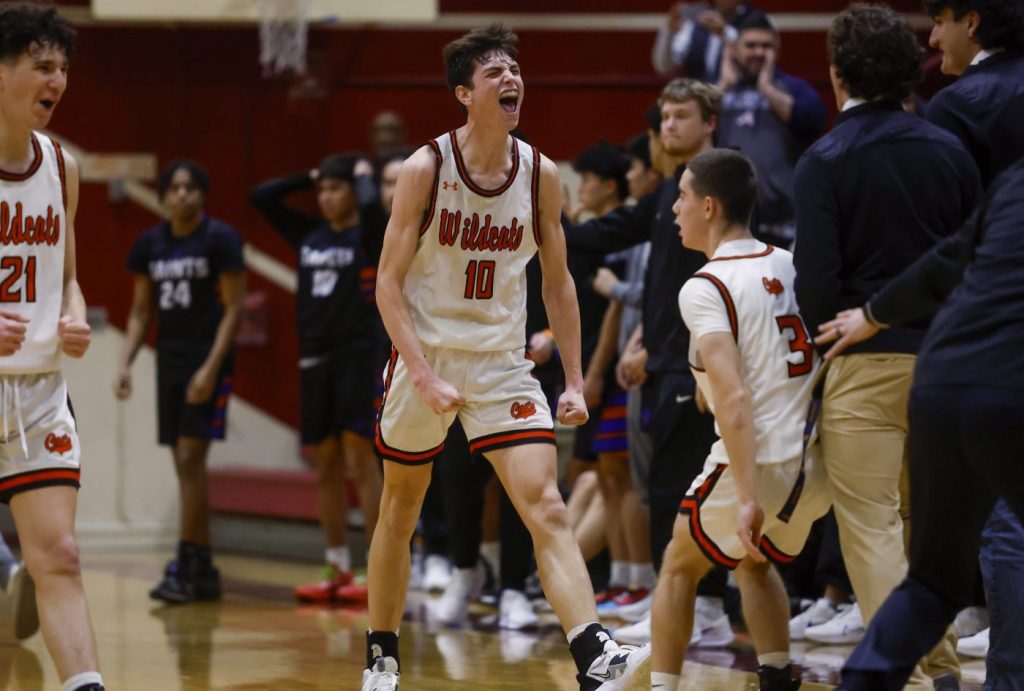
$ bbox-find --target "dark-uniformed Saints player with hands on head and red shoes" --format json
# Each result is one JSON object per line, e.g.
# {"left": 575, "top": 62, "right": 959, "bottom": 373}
{"left": 251, "top": 155, "right": 386, "bottom": 602}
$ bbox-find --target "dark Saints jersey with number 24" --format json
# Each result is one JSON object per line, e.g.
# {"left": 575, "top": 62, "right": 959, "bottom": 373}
{"left": 127, "top": 216, "right": 245, "bottom": 357}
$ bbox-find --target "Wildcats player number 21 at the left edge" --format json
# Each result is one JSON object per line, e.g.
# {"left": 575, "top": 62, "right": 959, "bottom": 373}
{"left": 0, "top": 3, "right": 103, "bottom": 691}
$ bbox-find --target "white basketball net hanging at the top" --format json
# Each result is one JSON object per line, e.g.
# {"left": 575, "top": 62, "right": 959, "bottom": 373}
{"left": 257, "top": 0, "right": 312, "bottom": 77}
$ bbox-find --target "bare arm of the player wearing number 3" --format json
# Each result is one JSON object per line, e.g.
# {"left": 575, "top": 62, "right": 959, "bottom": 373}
{"left": 697, "top": 332, "right": 765, "bottom": 562}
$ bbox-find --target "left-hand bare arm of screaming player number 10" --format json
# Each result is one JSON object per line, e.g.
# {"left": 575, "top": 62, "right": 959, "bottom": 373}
{"left": 377, "top": 146, "right": 464, "bottom": 414}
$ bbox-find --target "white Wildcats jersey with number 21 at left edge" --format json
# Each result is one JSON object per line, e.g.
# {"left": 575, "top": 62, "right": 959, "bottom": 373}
{"left": 0, "top": 132, "right": 68, "bottom": 374}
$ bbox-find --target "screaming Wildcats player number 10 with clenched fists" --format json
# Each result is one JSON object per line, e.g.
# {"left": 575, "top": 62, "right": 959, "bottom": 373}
{"left": 362, "top": 25, "right": 648, "bottom": 691}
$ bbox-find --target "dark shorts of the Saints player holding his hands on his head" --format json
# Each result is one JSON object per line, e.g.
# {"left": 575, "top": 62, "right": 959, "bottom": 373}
{"left": 299, "top": 353, "right": 384, "bottom": 444}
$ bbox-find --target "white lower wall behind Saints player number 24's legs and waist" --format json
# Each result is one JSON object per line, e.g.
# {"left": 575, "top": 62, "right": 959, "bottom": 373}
{"left": 63, "top": 327, "right": 303, "bottom": 549}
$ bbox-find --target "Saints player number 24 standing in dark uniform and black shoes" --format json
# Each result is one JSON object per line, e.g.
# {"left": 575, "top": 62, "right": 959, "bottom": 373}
{"left": 114, "top": 161, "right": 245, "bottom": 604}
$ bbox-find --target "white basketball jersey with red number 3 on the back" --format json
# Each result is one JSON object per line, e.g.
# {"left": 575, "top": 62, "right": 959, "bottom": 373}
{"left": 679, "top": 240, "right": 819, "bottom": 464}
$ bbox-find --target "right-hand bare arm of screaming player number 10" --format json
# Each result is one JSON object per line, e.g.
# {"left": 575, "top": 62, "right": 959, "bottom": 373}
{"left": 539, "top": 157, "right": 587, "bottom": 425}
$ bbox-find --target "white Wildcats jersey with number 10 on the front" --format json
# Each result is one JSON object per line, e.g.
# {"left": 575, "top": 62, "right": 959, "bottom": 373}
{"left": 403, "top": 132, "right": 541, "bottom": 351}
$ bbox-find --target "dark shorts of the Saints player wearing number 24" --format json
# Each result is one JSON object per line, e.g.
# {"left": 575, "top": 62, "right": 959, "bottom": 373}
{"left": 157, "top": 355, "right": 234, "bottom": 446}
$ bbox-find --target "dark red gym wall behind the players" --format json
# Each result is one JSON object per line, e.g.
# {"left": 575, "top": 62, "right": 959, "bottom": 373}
{"left": 51, "top": 0, "right": 937, "bottom": 432}
